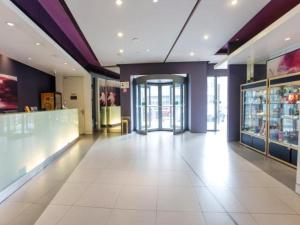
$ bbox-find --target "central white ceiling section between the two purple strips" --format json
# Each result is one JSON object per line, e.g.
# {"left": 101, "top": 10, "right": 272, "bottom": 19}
{"left": 65, "top": 0, "right": 270, "bottom": 66}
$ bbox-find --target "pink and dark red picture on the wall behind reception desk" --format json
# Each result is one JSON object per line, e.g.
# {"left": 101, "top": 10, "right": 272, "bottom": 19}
{"left": 0, "top": 74, "right": 18, "bottom": 111}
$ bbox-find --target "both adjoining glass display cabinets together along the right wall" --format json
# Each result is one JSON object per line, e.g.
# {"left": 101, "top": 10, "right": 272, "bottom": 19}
{"left": 240, "top": 78, "right": 300, "bottom": 167}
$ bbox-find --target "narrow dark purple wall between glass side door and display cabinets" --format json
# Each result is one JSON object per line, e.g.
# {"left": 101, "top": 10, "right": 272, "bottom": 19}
{"left": 227, "top": 65, "right": 247, "bottom": 141}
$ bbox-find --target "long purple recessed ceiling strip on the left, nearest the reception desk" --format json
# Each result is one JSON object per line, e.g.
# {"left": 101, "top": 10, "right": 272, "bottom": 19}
{"left": 12, "top": 0, "right": 118, "bottom": 79}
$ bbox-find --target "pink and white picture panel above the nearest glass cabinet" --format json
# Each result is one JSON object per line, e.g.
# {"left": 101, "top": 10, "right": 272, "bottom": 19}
{"left": 267, "top": 49, "right": 300, "bottom": 78}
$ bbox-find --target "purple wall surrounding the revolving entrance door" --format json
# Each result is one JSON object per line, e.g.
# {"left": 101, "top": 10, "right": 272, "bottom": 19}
{"left": 120, "top": 62, "right": 208, "bottom": 133}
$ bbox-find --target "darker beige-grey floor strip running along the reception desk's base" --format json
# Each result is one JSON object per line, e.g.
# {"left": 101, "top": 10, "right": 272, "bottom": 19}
{"left": 0, "top": 134, "right": 99, "bottom": 225}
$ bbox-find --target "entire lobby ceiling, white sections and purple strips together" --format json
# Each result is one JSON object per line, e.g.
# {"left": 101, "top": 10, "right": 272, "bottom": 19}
{"left": 0, "top": 0, "right": 300, "bottom": 75}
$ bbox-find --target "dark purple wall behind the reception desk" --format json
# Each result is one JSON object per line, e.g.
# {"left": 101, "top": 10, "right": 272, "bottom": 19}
{"left": 0, "top": 55, "right": 55, "bottom": 112}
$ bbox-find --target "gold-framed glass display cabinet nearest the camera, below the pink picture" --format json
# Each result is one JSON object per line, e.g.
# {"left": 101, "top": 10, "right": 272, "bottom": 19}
{"left": 268, "top": 74, "right": 300, "bottom": 166}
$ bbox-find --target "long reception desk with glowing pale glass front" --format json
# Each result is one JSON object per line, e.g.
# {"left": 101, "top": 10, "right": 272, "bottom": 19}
{"left": 0, "top": 109, "right": 79, "bottom": 202}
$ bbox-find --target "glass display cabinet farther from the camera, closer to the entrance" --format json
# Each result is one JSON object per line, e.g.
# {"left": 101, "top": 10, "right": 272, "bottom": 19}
{"left": 240, "top": 80, "right": 267, "bottom": 154}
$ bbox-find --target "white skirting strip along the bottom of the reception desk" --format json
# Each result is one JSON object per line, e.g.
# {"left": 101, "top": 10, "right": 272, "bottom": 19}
{"left": 0, "top": 137, "right": 79, "bottom": 203}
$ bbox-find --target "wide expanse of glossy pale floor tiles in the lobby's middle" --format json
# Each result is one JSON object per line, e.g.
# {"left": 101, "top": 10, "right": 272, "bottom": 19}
{"left": 0, "top": 132, "right": 300, "bottom": 225}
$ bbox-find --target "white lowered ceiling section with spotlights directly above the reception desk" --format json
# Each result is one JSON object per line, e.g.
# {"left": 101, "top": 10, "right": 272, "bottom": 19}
{"left": 0, "top": 0, "right": 88, "bottom": 76}
